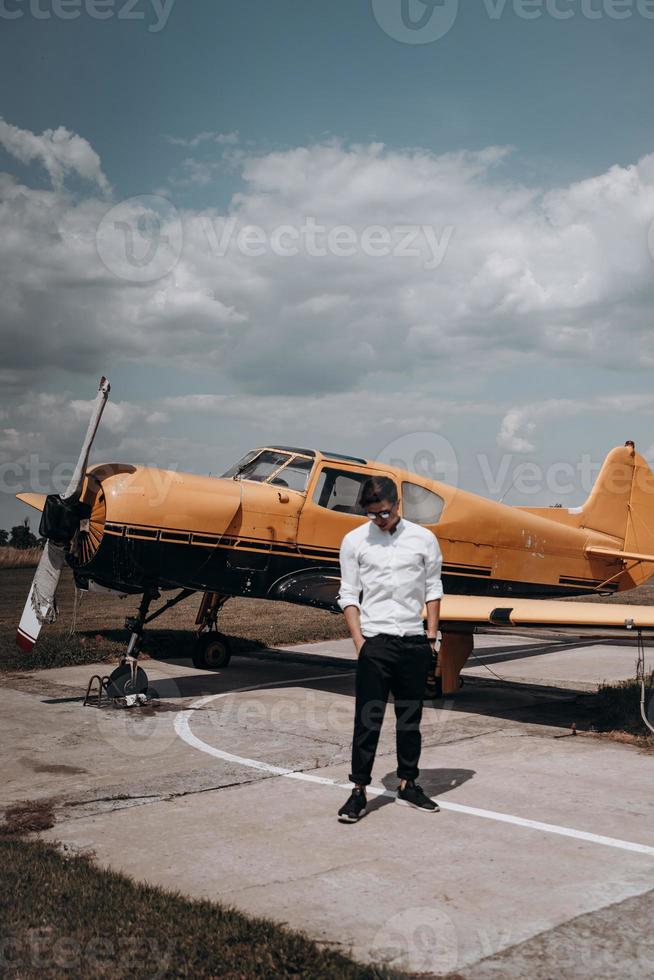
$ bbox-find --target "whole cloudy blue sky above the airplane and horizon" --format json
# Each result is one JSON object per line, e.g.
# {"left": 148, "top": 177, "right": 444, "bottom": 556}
{"left": 0, "top": 0, "right": 654, "bottom": 527}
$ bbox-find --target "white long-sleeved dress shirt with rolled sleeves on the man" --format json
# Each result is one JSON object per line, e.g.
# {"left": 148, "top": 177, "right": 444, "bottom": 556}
{"left": 338, "top": 518, "right": 443, "bottom": 637}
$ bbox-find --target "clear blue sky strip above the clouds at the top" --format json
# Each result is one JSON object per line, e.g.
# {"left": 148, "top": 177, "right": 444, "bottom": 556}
{"left": 5, "top": 0, "right": 654, "bottom": 193}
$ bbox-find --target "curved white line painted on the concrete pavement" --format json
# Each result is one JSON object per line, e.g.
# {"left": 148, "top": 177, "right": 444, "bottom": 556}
{"left": 175, "top": 671, "right": 654, "bottom": 856}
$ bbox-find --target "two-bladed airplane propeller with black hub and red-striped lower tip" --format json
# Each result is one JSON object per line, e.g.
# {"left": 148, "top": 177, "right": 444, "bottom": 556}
{"left": 16, "top": 377, "right": 111, "bottom": 651}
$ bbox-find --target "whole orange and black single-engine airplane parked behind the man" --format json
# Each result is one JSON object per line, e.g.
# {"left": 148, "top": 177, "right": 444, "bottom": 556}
{"left": 17, "top": 378, "right": 654, "bottom": 696}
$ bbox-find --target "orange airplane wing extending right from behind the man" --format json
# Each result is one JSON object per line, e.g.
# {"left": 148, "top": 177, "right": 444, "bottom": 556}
{"left": 440, "top": 595, "right": 654, "bottom": 633}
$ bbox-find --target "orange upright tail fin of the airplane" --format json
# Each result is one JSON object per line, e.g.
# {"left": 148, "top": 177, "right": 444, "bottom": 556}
{"left": 578, "top": 442, "right": 654, "bottom": 587}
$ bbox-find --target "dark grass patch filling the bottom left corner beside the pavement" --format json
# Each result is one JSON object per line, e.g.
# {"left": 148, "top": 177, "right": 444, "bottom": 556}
{"left": 0, "top": 837, "right": 405, "bottom": 980}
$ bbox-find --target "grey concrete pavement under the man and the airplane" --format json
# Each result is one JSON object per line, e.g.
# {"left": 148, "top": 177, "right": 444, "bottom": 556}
{"left": 0, "top": 636, "right": 654, "bottom": 978}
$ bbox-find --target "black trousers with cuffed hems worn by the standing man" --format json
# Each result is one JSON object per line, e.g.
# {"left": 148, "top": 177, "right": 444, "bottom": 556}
{"left": 350, "top": 633, "right": 432, "bottom": 786}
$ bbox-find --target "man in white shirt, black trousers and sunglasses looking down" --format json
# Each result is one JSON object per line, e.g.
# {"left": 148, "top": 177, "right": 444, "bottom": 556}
{"left": 338, "top": 477, "right": 443, "bottom": 823}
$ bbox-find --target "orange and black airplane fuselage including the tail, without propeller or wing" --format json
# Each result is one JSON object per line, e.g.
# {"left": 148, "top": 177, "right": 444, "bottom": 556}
{"left": 68, "top": 446, "right": 654, "bottom": 608}
